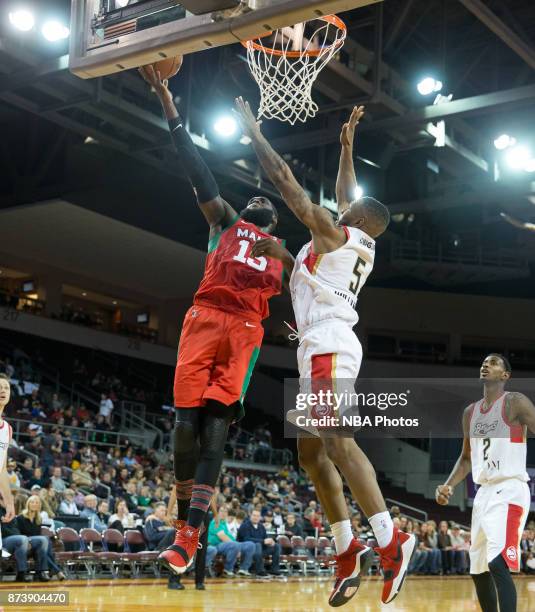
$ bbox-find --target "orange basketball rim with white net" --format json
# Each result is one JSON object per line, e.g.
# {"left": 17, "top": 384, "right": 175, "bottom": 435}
{"left": 242, "top": 15, "right": 347, "bottom": 125}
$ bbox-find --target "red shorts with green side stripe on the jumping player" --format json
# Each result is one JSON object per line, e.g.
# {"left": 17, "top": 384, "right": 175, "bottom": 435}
{"left": 174, "top": 305, "right": 264, "bottom": 408}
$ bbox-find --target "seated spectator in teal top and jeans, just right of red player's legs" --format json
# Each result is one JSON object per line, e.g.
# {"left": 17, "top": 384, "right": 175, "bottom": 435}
{"left": 206, "top": 506, "right": 255, "bottom": 578}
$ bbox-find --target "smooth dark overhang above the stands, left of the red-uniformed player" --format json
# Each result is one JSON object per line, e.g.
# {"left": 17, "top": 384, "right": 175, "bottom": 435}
{"left": 0, "top": 200, "right": 205, "bottom": 304}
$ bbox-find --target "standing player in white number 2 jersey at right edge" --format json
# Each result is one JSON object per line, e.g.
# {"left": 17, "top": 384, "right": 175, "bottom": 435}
{"left": 436, "top": 353, "right": 535, "bottom": 612}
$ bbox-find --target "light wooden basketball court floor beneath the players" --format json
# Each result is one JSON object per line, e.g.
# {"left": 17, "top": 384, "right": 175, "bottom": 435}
{"left": 5, "top": 576, "right": 535, "bottom": 612}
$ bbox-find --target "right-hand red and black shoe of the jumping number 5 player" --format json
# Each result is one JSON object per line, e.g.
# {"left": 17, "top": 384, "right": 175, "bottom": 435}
{"left": 374, "top": 527, "right": 416, "bottom": 603}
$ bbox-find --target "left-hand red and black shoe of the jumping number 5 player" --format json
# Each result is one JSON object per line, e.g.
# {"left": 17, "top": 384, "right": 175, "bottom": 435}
{"left": 329, "top": 538, "right": 373, "bottom": 608}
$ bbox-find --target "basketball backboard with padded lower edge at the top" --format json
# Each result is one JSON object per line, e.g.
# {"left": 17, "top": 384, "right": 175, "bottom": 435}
{"left": 69, "top": 0, "right": 382, "bottom": 79}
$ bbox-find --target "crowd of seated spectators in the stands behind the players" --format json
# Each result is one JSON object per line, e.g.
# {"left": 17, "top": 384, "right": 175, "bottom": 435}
{"left": 0, "top": 359, "right": 535, "bottom": 580}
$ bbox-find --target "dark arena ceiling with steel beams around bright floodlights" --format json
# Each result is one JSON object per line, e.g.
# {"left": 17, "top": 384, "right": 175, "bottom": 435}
{"left": 0, "top": 0, "right": 535, "bottom": 296}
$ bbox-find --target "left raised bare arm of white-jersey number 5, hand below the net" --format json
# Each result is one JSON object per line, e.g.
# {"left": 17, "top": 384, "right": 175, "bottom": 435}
{"left": 236, "top": 97, "right": 345, "bottom": 250}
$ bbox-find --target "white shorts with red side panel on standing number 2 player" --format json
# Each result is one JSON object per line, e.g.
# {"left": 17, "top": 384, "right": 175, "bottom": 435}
{"left": 470, "top": 478, "right": 531, "bottom": 574}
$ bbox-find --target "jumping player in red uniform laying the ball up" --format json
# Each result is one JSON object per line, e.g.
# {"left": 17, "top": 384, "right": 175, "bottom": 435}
{"left": 136, "top": 66, "right": 293, "bottom": 574}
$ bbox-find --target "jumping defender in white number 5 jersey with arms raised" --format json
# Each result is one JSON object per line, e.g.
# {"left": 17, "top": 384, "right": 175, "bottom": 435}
{"left": 236, "top": 98, "right": 415, "bottom": 606}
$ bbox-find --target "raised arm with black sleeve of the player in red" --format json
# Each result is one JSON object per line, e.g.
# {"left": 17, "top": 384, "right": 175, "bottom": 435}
{"left": 139, "top": 65, "right": 237, "bottom": 233}
